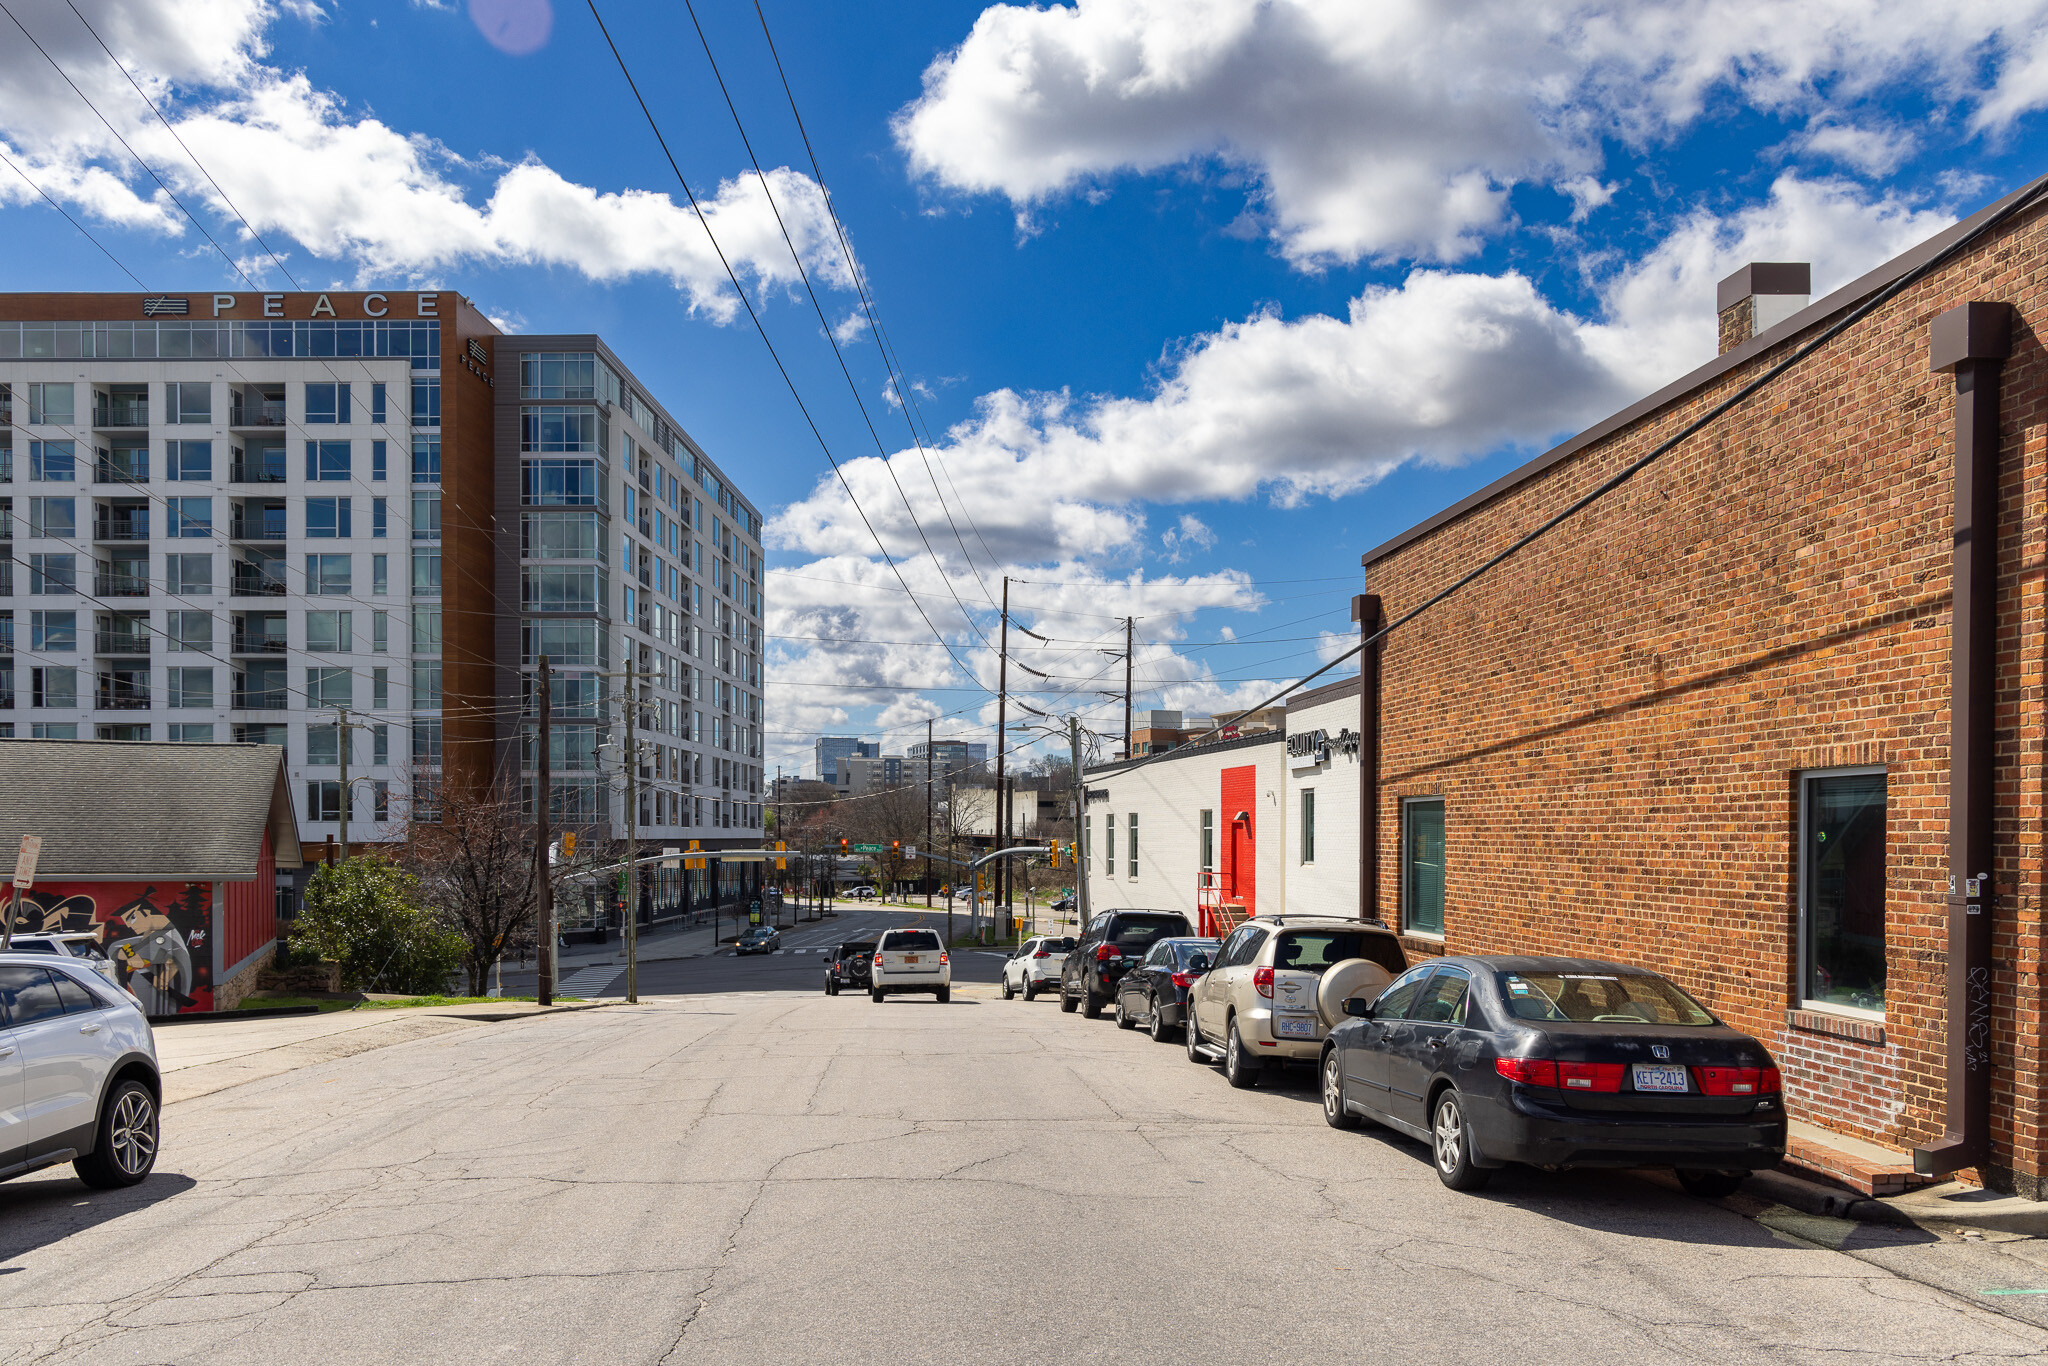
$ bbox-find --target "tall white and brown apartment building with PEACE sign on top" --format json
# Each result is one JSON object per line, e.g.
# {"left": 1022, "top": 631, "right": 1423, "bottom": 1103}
{"left": 0, "top": 291, "right": 762, "bottom": 872}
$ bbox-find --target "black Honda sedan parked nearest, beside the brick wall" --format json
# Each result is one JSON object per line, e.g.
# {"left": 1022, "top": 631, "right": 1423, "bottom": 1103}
{"left": 1323, "top": 956, "right": 1786, "bottom": 1196}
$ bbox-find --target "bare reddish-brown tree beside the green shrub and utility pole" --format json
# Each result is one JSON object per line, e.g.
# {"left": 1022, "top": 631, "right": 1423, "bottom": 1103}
{"left": 403, "top": 776, "right": 539, "bottom": 995}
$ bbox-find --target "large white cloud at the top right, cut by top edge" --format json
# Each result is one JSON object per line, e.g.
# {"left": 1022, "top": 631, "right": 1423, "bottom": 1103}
{"left": 895, "top": 0, "right": 2048, "bottom": 266}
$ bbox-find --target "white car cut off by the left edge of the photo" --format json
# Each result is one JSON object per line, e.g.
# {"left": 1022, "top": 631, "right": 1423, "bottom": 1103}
{"left": 0, "top": 952, "right": 164, "bottom": 1188}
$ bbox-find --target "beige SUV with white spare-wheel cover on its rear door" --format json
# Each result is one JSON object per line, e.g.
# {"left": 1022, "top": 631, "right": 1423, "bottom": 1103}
{"left": 1188, "top": 915, "right": 1407, "bottom": 1087}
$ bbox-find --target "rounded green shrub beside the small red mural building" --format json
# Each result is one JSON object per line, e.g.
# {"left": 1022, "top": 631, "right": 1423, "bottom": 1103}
{"left": 291, "top": 856, "right": 463, "bottom": 995}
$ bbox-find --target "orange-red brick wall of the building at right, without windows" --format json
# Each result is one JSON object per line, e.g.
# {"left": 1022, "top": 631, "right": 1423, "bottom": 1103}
{"left": 1368, "top": 200, "right": 2048, "bottom": 1194}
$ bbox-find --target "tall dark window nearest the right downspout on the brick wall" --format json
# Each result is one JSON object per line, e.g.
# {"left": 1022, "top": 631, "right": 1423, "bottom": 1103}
{"left": 1800, "top": 768, "right": 1884, "bottom": 1014}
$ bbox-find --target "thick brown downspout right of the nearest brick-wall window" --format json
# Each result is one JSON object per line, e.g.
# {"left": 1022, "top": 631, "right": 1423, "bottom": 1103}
{"left": 1913, "top": 303, "right": 2011, "bottom": 1176}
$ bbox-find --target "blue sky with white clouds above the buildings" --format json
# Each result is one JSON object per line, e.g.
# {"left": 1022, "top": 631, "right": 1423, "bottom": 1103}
{"left": 0, "top": 0, "right": 2048, "bottom": 772}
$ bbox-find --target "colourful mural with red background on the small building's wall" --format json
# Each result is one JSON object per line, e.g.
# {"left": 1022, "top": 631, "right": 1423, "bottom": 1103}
{"left": 20, "top": 883, "right": 213, "bottom": 1016}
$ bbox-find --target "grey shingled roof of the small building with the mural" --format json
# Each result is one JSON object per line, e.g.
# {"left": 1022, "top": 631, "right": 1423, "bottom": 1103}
{"left": 0, "top": 739, "right": 301, "bottom": 883}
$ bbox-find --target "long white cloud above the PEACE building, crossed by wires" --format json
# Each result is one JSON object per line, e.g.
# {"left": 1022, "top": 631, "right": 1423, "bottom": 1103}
{"left": 0, "top": 0, "right": 852, "bottom": 322}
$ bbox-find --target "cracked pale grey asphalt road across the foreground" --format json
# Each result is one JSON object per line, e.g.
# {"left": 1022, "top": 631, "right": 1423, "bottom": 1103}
{"left": 0, "top": 958, "right": 2048, "bottom": 1366}
